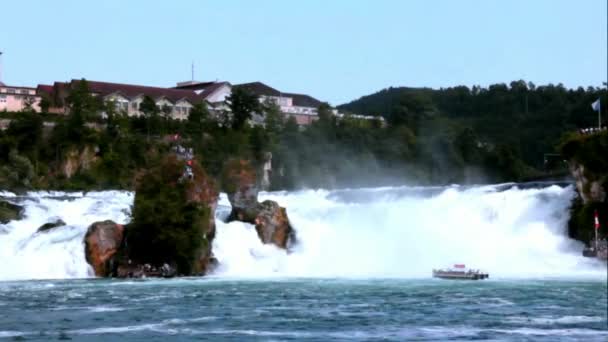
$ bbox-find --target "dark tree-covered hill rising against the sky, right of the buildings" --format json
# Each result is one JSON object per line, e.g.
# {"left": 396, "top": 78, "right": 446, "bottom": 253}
{"left": 338, "top": 80, "right": 608, "bottom": 168}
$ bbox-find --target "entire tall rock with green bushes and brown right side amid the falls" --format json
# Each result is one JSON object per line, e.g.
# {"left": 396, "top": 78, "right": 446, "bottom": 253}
{"left": 114, "top": 154, "right": 219, "bottom": 277}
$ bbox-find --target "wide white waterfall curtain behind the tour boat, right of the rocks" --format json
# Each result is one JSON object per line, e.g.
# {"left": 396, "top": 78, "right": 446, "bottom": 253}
{"left": 214, "top": 186, "right": 605, "bottom": 280}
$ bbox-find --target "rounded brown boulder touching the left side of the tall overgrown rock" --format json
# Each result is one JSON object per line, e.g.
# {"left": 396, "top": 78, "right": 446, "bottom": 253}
{"left": 84, "top": 220, "right": 124, "bottom": 277}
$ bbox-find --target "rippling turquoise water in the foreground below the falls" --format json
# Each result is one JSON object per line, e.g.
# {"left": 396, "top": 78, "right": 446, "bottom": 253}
{"left": 0, "top": 278, "right": 608, "bottom": 341}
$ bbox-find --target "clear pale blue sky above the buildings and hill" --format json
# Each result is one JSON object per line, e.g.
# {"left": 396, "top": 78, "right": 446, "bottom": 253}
{"left": 0, "top": 0, "right": 608, "bottom": 105}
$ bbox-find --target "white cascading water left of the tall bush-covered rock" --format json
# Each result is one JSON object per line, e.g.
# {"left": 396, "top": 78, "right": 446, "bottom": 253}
{"left": 0, "top": 191, "right": 133, "bottom": 280}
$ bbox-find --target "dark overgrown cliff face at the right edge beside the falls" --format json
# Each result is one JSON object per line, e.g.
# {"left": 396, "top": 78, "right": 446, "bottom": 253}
{"left": 560, "top": 131, "right": 608, "bottom": 243}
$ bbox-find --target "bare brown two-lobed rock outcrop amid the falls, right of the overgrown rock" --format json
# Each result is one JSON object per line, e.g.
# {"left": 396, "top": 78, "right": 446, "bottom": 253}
{"left": 222, "top": 160, "right": 295, "bottom": 249}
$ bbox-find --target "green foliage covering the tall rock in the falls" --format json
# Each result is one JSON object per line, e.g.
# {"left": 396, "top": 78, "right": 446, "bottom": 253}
{"left": 126, "top": 157, "right": 210, "bottom": 275}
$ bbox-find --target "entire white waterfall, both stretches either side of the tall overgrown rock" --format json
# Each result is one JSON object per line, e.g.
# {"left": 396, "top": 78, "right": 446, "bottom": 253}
{"left": 0, "top": 186, "right": 606, "bottom": 280}
